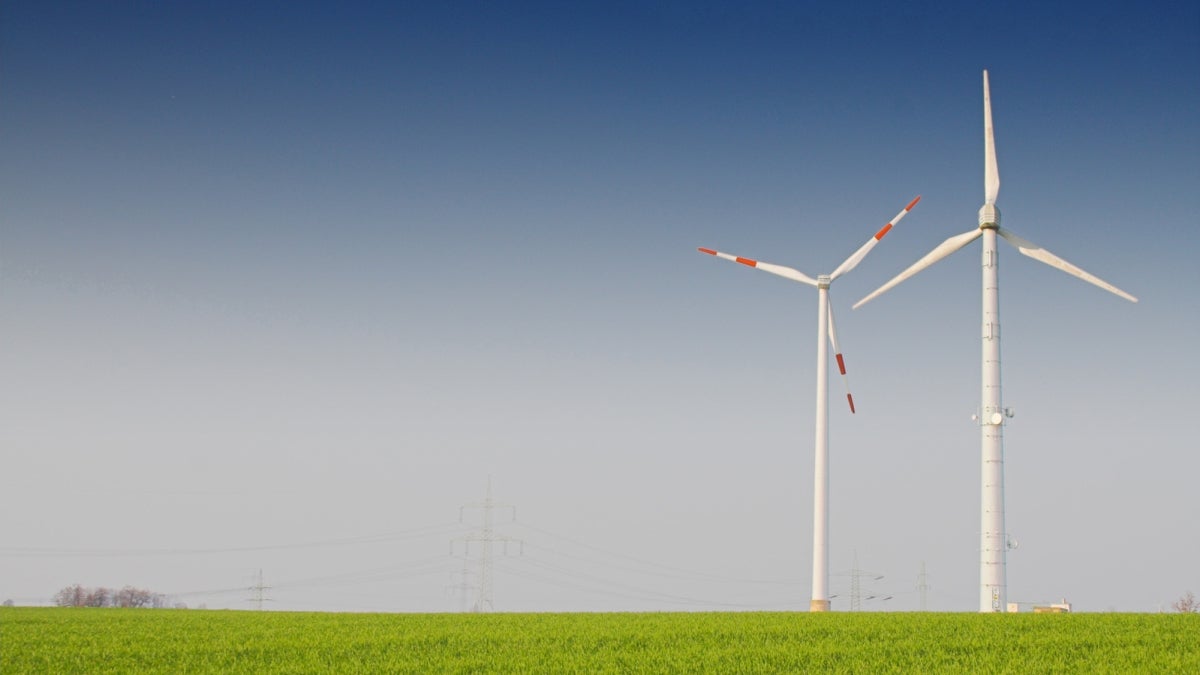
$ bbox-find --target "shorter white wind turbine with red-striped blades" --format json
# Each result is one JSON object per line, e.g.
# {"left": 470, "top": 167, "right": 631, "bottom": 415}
{"left": 700, "top": 197, "right": 920, "bottom": 611}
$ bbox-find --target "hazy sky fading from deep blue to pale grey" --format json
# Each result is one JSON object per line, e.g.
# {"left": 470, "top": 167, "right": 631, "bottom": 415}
{"left": 0, "top": 0, "right": 1200, "bottom": 611}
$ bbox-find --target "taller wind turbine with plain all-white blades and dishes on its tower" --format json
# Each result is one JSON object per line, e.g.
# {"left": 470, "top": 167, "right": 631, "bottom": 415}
{"left": 854, "top": 71, "right": 1138, "bottom": 611}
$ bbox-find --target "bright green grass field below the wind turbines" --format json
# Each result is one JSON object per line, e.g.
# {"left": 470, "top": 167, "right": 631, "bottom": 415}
{"left": 0, "top": 608, "right": 1200, "bottom": 674}
